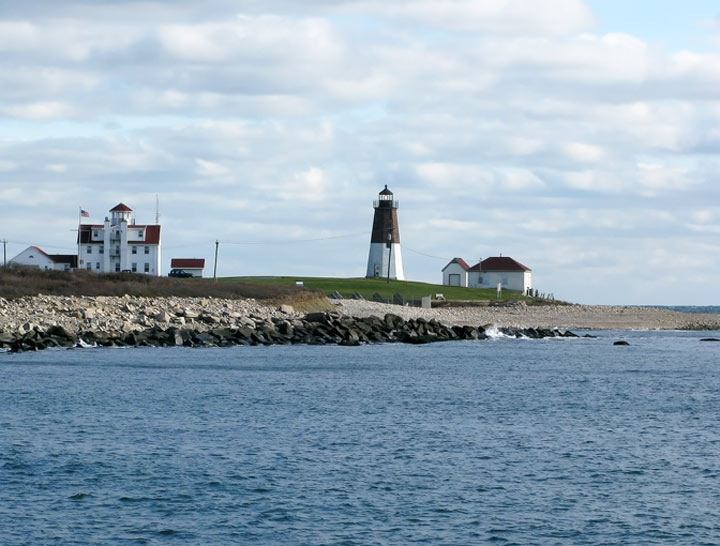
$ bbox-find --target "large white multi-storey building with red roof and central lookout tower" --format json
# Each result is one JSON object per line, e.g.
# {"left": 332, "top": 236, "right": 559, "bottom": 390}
{"left": 78, "top": 203, "right": 162, "bottom": 276}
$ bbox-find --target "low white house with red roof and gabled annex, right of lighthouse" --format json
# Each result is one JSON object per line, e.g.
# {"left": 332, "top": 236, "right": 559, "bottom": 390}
{"left": 442, "top": 256, "right": 532, "bottom": 292}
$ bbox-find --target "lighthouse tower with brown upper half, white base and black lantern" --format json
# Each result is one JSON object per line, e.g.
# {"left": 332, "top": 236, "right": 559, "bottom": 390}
{"left": 366, "top": 186, "right": 405, "bottom": 281}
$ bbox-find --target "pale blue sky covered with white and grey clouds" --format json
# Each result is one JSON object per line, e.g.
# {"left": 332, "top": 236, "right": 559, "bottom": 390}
{"left": 0, "top": 0, "right": 720, "bottom": 305}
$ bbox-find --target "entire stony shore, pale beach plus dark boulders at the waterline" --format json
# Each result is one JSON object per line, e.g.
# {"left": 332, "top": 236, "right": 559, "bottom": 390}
{"left": 0, "top": 296, "right": 720, "bottom": 352}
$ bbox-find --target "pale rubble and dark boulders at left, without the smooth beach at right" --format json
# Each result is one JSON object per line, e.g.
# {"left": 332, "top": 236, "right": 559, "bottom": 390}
{"left": 0, "top": 296, "right": 577, "bottom": 352}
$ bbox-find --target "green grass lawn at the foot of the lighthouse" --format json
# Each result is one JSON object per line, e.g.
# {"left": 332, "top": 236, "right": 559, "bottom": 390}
{"left": 218, "top": 277, "right": 533, "bottom": 301}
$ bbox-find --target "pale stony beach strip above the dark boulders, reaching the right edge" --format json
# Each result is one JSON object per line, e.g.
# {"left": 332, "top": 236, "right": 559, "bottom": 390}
{"left": 0, "top": 295, "right": 720, "bottom": 334}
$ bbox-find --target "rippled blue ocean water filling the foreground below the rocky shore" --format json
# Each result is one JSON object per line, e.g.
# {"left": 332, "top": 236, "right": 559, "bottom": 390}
{"left": 0, "top": 332, "right": 720, "bottom": 545}
